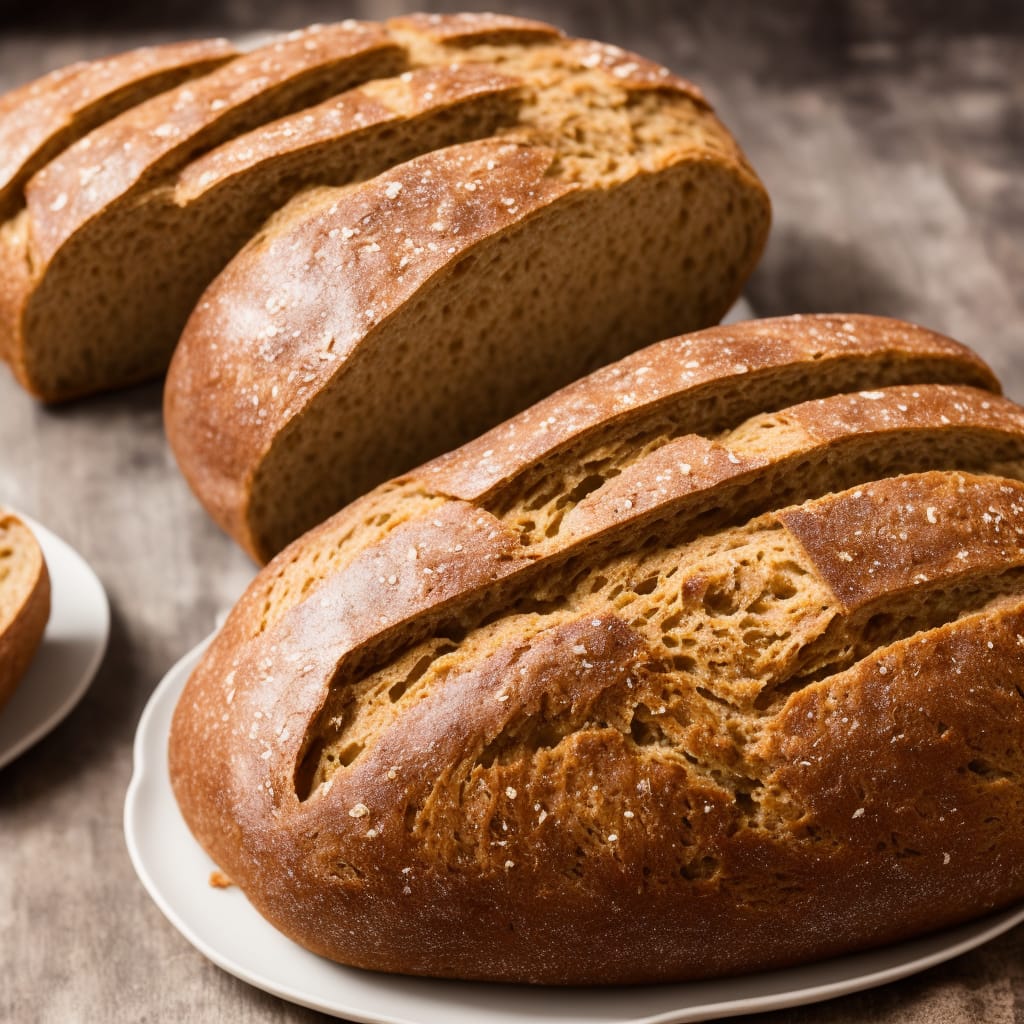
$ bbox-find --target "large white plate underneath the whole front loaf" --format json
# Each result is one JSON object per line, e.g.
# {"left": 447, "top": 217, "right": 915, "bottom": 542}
{"left": 125, "top": 643, "right": 1024, "bottom": 1024}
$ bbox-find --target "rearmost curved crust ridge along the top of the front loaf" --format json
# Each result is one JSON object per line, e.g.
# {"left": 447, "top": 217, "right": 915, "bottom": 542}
{"left": 417, "top": 314, "right": 999, "bottom": 501}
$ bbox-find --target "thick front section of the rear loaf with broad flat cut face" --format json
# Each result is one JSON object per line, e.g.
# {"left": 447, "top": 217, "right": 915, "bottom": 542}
{"left": 165, "top": 19, "right": 768, "bottom": 557}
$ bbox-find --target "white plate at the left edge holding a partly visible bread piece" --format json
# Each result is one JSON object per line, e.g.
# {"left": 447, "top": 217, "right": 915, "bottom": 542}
{"left": 0, "top": 520, "right": 111, "bottom": 768}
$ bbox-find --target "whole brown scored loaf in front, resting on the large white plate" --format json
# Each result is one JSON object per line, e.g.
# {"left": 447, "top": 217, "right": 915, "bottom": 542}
{"left": 169, "top": 316, "right": 1024, "bottom": 984}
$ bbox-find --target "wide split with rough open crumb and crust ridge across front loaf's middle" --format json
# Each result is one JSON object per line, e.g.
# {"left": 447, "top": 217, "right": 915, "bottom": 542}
{"left": 303, "top": 473, "right": 1024, "bottom": 797}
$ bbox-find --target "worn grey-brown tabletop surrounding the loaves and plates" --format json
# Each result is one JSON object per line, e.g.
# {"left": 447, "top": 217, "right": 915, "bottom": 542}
{"left": 0, "top": 0, "right": 1024, "bottom": 1024}
